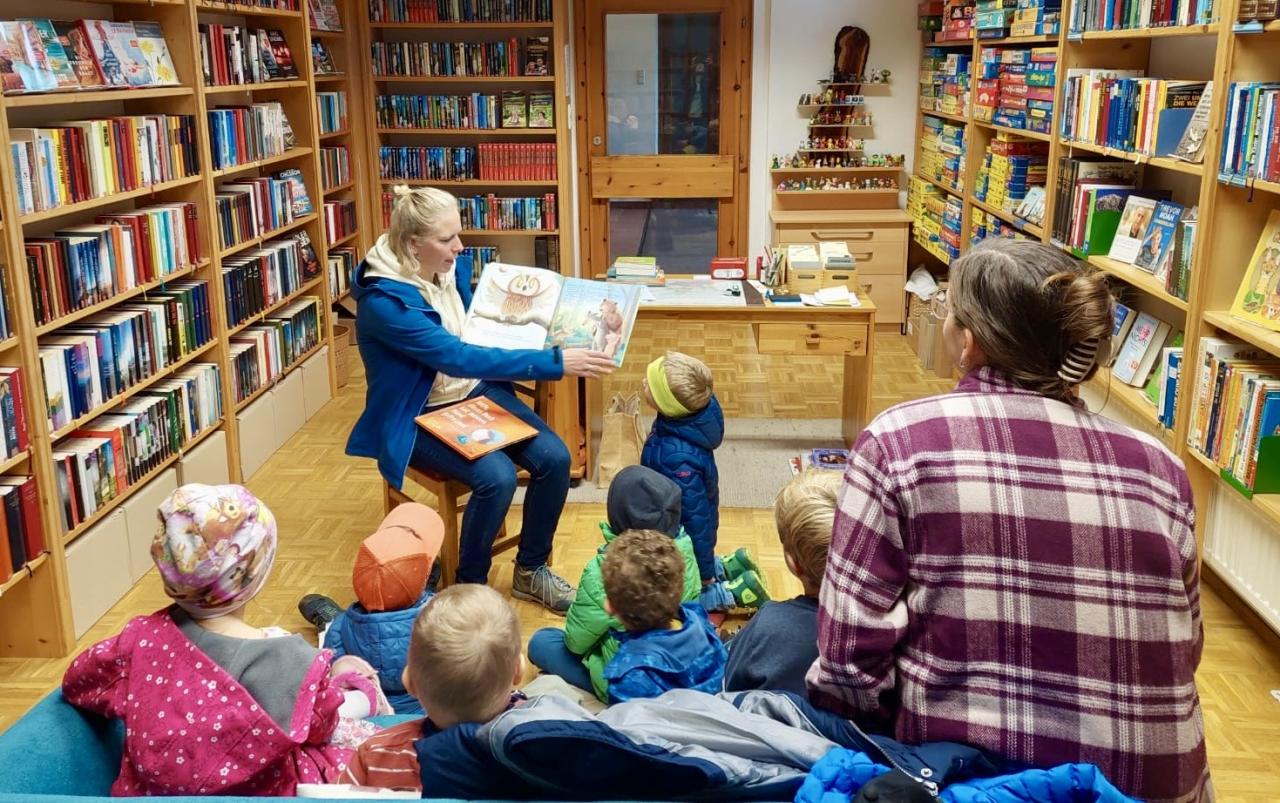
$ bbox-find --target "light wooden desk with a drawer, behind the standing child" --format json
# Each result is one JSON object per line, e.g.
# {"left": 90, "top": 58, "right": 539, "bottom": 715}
{"left": 585, "top": 283, "right": 876, "bottom": 478}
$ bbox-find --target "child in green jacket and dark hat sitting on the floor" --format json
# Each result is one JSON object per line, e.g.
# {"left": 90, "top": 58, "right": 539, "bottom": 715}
{"left": 529, "top": 466, "right": 769, "bottom": 702}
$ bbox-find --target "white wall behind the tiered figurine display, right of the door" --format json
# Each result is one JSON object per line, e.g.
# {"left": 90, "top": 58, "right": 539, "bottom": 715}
{"left": 748, "top": 0, "right": 920, "bottom": 256}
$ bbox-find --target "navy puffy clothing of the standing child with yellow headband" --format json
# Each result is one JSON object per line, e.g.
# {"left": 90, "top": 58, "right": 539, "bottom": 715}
{"left": 640, "top": 394, "right": 724, "bottom": 581}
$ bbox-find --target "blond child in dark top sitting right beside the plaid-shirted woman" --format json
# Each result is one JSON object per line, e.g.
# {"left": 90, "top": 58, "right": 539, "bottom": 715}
{"left": 724, "top": 469, "right": 844, "bottom": 697}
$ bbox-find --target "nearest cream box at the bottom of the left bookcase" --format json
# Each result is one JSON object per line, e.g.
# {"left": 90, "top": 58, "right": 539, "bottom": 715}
{"left": 67, "top": 510, "right": 131, "bottom": 638}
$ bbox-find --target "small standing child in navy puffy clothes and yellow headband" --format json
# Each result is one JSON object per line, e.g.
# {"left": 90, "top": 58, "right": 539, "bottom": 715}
{"left": 640, "top": 351, "right": 769, "bottom": 608}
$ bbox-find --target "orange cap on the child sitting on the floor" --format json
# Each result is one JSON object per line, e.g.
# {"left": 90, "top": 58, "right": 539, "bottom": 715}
{"left": 351, "top": 502, "right": 444, "bottom": 611}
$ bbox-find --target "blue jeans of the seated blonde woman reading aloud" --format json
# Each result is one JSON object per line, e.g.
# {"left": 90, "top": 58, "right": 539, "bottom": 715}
{"left": 410, "top": 382, "right": 570, "bottom": 583}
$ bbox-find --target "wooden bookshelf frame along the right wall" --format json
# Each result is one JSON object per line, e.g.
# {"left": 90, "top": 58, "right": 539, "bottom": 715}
{"left": 916, "top": 0, "right": 1280, "bottom": 591}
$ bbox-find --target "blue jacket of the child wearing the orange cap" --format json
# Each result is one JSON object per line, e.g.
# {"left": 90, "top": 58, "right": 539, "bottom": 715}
{"left": 324, "top": 592, "right": 431, "bottom": 716}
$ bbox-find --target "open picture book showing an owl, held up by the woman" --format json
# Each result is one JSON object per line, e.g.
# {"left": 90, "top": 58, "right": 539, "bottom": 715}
{"left": 462, "top": 263, "right": 643, "bottom": 366}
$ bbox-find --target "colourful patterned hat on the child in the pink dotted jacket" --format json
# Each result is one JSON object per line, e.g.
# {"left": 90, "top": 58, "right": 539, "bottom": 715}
{"left": 151, "top": 483, "right": 276, "bottom": 619}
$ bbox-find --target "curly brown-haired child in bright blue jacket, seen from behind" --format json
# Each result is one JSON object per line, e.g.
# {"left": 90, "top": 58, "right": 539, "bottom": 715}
{"left": 602, "top": 530, "right": 728, "bottom": 704}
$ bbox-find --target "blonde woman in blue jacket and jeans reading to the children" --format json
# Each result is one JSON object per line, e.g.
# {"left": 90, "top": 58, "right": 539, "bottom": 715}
{"left": 347, "top": 186, "right": 613, "bottom": 615}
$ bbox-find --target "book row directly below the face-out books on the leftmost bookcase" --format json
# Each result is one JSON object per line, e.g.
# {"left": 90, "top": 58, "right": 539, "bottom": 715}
{"left": 9, "top": 114, "right": 200, "bottom": 214}
